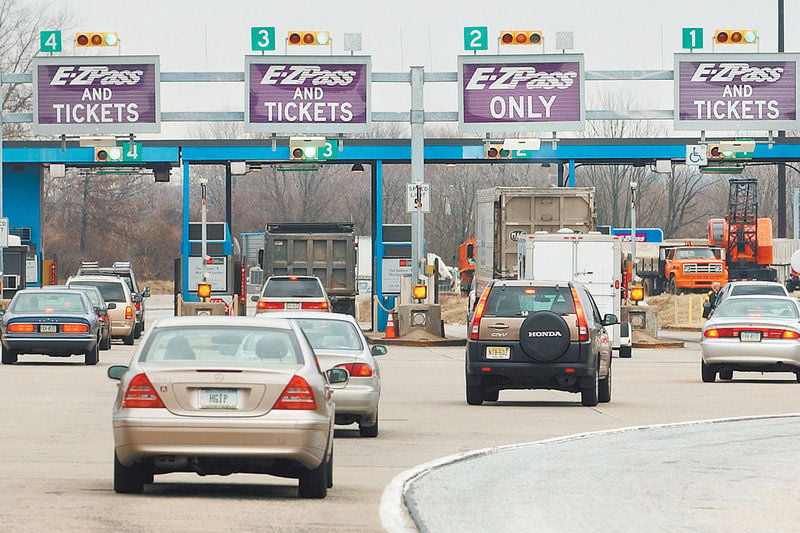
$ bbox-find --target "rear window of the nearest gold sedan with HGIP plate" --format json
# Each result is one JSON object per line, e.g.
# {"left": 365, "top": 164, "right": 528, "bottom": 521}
{"left": 139, "top": 326, "right": 303, "bottom": 366}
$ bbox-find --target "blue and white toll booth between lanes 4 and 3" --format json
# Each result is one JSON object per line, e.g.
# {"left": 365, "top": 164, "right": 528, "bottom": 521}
{"left": 175, "top": 222, "right": 246, "bottom": 314}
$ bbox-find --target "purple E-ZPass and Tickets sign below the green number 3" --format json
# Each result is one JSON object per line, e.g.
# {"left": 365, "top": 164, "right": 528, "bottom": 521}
{"left": 245, "top": 56, "right": 371, "bottom": 133}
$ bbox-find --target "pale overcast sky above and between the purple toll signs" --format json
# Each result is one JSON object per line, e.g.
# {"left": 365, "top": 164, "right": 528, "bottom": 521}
{"left": 42, "top": 0, "right": 800, "bottom": 137}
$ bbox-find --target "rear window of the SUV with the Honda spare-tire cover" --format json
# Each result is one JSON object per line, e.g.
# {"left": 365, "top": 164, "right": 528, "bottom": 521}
{"left": 484, "top": 285, "right": 575, "bottom": 317}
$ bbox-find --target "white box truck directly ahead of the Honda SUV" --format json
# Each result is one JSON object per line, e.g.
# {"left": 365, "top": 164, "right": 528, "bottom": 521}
{"left": 517, "top": 229, "right": 631, "bottom": 357}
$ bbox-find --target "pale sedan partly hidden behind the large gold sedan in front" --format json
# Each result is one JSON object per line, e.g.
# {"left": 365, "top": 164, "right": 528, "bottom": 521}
{"left": 256, "top": 311, "right": 386, "bottom": 437}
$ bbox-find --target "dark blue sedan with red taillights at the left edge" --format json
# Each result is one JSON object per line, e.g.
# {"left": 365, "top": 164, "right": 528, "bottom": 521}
{"left": 0, "top": 289, "right": 102, "bottom": 365}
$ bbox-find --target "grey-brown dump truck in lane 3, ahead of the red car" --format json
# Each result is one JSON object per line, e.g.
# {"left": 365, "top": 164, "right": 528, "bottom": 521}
{"left": 258, "top": 222, "right": 358, "bottom": 316}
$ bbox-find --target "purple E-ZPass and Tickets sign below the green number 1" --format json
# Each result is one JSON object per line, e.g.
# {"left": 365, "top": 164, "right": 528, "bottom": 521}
{"left": 675, "top": 54, "right": 800, "bottom": 130}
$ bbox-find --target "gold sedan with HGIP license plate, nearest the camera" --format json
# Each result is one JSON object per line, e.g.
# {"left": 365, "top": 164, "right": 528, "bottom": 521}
{"left": 108, "top": 317, "right": 348, "bottom": 498}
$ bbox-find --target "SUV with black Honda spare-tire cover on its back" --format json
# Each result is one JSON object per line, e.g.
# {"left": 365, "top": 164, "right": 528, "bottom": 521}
{"left": 466, "top": 279, "right": 617, "bottom": 406}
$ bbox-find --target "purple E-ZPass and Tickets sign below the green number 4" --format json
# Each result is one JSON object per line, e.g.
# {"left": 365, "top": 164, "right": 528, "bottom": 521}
{"left": 33, "top": 56, "right": 161, "bottom": 135}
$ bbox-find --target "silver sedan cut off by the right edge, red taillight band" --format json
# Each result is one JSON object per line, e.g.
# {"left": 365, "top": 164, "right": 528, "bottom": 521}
{"left": 700, "top": 296, "right": 800, "bottom": 383}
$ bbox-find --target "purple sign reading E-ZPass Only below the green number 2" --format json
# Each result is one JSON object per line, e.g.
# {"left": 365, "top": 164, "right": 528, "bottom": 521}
{"left": 458, "top": 54, "right": 584, "bottom": 132}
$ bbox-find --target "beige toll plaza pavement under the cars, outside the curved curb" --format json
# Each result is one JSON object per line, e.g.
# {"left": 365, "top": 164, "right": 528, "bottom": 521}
{"left": 0, "top": 296, "right": 800, "bottom": 532}
